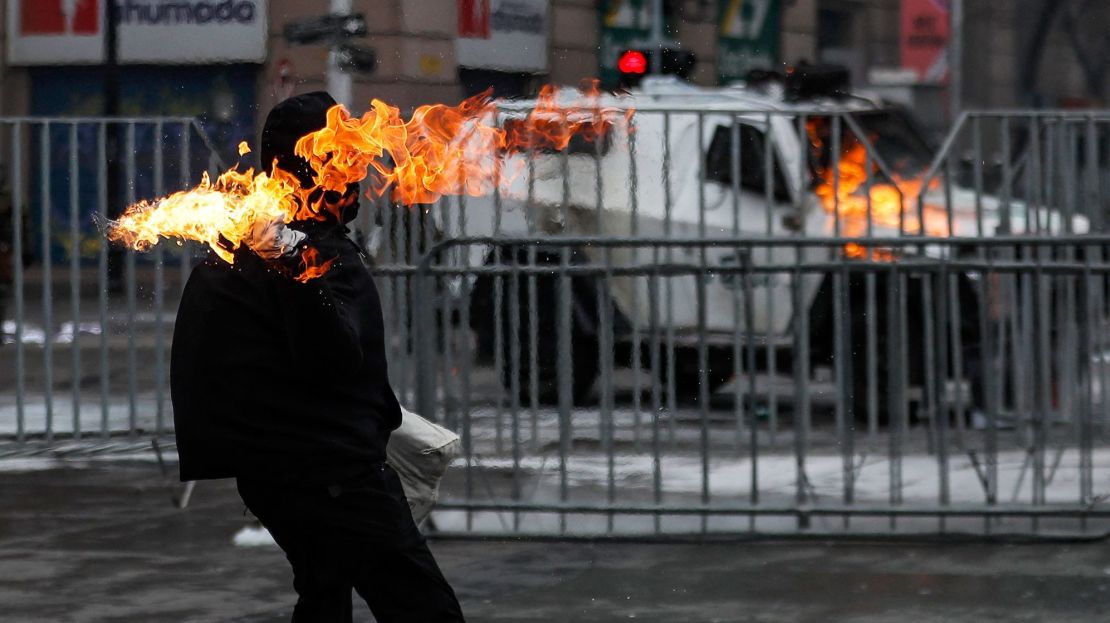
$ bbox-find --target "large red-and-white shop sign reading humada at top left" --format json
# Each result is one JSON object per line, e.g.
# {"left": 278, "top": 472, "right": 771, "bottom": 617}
{"left": 8, "top": 0, "right": 268, "bottom": 64}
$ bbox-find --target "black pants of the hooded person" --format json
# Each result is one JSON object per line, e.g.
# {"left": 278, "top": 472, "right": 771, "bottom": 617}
{"left": 238, "top": 464, "right": 463, "bottom": 623}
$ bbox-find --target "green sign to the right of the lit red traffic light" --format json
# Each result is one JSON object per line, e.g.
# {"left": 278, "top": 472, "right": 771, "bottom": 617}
{"left": 717, "top": 0, "right": 783, "bottom": 84}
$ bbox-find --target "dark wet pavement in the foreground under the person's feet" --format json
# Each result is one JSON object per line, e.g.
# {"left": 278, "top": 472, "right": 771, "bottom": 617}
{"left": 0, "top": 460, "right": 1110, "bottom": 623}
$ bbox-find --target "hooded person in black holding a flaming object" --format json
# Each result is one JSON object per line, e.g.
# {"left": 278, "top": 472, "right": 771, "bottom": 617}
{"left": 171, "top": 92, "right": 463, "bottom": 623}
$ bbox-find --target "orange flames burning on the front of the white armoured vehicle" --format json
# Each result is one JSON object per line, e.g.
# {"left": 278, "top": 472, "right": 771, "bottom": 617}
{"left": 807, "top": 120, "right": 949, "bottom": 259}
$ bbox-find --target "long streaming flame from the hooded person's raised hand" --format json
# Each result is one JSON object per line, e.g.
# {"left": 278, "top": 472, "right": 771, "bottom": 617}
{"left": 108, "top": 82, "right": 630, "bottom": 280}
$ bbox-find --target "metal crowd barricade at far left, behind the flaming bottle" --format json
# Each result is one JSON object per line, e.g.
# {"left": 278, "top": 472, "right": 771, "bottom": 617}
{"left": 0, "top": 117, "right": 223, "bottom": 454}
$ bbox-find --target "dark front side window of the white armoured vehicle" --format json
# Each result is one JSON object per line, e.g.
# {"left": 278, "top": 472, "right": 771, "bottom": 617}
{"left": 705, "top": 123, "right": 790, "bottom": 201}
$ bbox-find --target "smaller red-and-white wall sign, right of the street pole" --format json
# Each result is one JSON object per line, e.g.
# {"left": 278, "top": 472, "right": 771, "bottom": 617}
{"left": 455, "top": 0, "right": 549, "bottom": 71}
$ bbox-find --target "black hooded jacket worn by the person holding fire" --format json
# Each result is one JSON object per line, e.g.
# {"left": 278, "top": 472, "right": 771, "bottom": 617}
{"left": 170, "top": 92, "right": 401, "bottom": 484}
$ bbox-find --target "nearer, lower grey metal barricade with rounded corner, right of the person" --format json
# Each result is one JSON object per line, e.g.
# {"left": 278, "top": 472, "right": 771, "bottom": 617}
{"left": 415, "top": 235, "right": 1110, "bottom": 537}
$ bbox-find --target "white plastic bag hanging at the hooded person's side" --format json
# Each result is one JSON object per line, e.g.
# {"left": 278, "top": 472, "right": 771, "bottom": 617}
{"left": 385, "top": 406, "right": 460, "bottom": 524}
